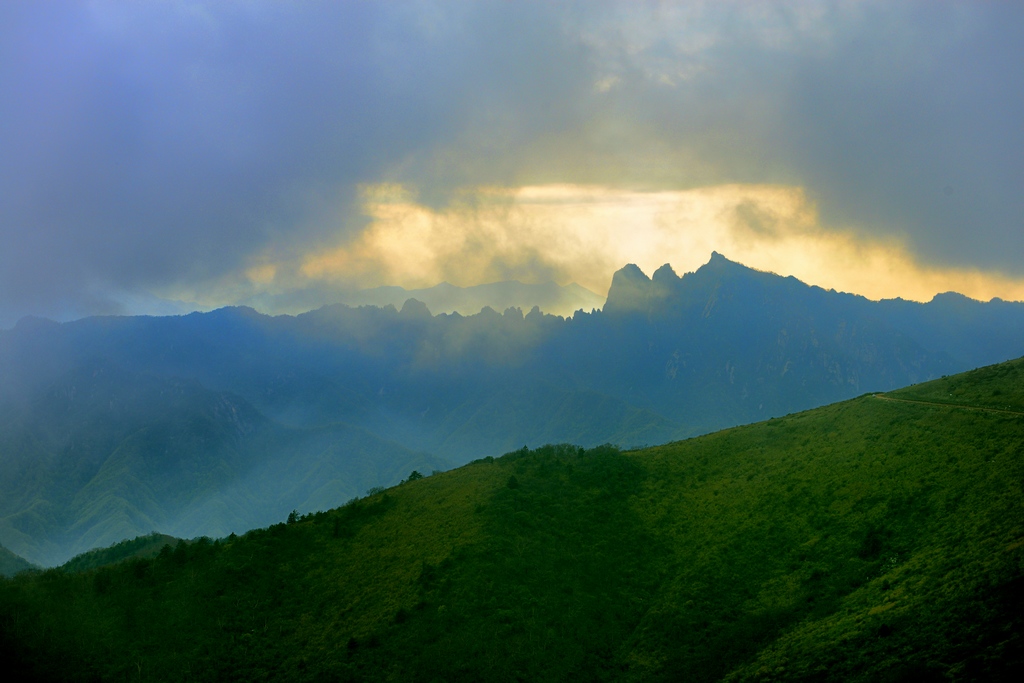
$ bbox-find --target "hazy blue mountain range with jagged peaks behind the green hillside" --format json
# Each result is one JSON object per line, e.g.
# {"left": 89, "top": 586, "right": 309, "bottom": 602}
{"left": 0, "top": 254, "right": 1024, "bottom": 565}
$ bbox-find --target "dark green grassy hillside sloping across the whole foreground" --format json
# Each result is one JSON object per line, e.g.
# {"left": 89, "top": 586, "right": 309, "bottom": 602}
{"left": 0, "top": 360, "right": 1024, "bottom": 681}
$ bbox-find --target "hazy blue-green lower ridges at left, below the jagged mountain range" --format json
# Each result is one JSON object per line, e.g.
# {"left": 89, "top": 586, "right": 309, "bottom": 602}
{"left": 0, "top": 361, "right": 445, "bottom": 565}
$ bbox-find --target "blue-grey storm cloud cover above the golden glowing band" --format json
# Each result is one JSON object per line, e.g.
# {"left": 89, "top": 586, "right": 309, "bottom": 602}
{"left": 0, "top": 2, "right": 1024, "bottom": 327}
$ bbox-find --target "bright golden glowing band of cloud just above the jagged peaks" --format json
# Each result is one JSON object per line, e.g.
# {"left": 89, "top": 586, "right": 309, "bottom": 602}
{"left": 292, "top": 184, "right": 1024, "bottom": 300}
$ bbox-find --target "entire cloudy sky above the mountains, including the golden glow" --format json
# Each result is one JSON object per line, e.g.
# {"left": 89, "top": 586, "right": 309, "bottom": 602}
{"left": 0, "top": 0, "right": 1024, "bottom": 329}
